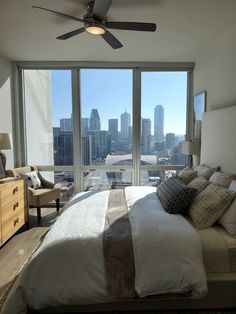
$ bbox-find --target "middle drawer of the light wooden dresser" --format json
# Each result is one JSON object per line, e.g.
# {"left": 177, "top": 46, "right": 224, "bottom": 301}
{"left": 1, "top": 195, "right": 25, "bottom": 224}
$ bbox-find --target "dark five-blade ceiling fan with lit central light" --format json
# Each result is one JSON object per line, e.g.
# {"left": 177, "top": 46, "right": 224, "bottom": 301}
{"left": 32, "top": 0, "right": 156, "bottom": 49}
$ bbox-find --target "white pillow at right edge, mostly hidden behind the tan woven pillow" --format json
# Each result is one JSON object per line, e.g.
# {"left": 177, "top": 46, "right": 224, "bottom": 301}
{"left": 218, "top": 181, "right": 236, "bottom": 238}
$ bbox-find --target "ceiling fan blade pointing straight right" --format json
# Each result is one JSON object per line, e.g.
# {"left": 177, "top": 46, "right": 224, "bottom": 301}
{"left": 106, "top": 22, "right": 157, "bottom": 32}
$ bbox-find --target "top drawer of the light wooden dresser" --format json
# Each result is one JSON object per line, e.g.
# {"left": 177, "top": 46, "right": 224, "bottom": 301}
{"left": 0, "top": 180, "right": 24, "bottom": 208}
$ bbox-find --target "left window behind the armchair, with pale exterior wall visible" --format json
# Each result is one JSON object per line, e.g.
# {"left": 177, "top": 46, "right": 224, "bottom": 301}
{"left": 22, "top": 70, "right": 74, "bottom": 201}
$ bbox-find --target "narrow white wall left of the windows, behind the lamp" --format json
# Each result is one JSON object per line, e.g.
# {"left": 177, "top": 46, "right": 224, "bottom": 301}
{"left": 0, "top": 56, "right": 14, "bottom": 169}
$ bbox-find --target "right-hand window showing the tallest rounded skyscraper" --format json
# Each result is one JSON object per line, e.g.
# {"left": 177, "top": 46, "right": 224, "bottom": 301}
{"left": 140, "top": 71, "right": 188, "bottom": 185}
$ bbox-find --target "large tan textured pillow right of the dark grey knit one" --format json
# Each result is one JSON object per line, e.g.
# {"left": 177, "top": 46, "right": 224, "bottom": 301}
{"left": 188, "top": 183, "right": 236, "bottom": 229}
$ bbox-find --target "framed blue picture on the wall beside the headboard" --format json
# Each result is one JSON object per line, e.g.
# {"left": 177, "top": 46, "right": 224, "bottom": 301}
{"left": 193, "top": 91, "right": 206, "bottom": 141}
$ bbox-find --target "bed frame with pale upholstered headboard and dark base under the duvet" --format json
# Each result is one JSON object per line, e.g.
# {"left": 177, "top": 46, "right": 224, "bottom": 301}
{"left": 30, "top": 106, "right": 236, "bottom": 313}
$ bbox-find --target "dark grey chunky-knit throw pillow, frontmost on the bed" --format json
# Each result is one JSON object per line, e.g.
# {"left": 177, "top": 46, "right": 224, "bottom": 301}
{"left": 157, "top": 177, "right": 197, "bottom": 214}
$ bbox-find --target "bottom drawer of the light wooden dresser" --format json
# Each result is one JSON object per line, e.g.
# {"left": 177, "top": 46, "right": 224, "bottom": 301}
{"left": 2, "top": 211, "right": 25, "bottom": 242}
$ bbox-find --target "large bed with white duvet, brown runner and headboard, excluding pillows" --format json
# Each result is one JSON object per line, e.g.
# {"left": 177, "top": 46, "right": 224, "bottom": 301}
{"left": 3, "top": 107, "right": 236, "bottom": 314}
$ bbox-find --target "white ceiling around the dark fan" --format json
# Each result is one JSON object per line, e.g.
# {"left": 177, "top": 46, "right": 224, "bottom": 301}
{"left": 0, "top": 0, "right": 236, "bottom": 62}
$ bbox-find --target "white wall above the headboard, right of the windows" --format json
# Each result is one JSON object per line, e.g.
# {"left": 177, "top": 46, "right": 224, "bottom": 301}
{"left": 194, "top": 25, "right": 236, "bottom": 111}
